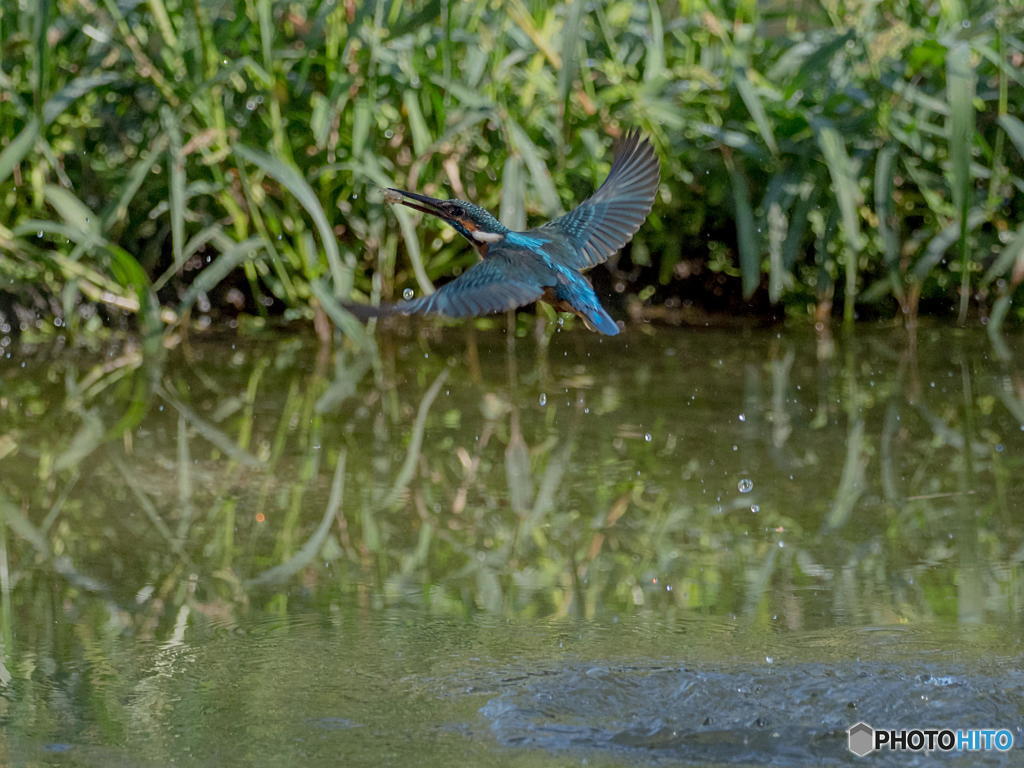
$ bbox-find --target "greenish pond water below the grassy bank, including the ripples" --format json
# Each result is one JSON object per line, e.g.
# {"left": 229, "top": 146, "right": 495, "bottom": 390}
{"left": 0, "top": 327, "right": 1024, "bottom": 766}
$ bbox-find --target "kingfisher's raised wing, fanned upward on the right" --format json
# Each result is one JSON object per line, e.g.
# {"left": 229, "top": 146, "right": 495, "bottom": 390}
{"left": 539, "top": 131, "right": 660, "bottom": 269}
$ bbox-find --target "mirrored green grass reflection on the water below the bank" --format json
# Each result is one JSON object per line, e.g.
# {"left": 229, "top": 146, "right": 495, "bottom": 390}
{"left": 4, "top": 331, "right": 1021, "bottom": 635}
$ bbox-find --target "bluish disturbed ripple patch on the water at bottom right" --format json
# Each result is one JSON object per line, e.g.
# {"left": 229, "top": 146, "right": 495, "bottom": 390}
{"left": 480, "top": 663, "right": 1024, "bottom": 766}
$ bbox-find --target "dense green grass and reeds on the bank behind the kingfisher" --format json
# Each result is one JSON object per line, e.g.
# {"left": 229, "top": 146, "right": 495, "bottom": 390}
{"left": 0, "top": 0, "right": 1024, "bottom": 332}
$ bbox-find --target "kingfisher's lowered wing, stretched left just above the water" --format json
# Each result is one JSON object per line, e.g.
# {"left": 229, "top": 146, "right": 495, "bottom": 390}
{"left": 346, "top": 247, "right": 554, "bottom": 318}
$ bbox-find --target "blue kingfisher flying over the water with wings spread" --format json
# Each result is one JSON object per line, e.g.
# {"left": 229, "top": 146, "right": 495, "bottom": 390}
{"left": 348, "top": 131, "right": 659, "bottom": 336}
